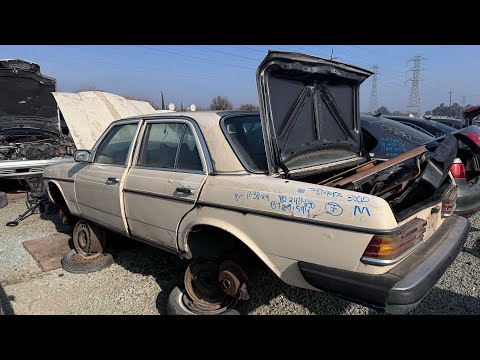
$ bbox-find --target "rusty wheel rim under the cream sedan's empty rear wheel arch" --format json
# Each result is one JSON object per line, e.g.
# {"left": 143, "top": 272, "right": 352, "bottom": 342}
{"left": 182, "top": 259, "right": 236, "bottom": 314}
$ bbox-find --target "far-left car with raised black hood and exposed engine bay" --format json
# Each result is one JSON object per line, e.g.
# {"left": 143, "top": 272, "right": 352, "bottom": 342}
{"left": 0, "top": 60, "right": 75, "bottom": 179}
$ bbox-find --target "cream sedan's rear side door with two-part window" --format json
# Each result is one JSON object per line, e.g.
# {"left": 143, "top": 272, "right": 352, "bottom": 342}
{"left": 124, "top": 120, "right": 206, "bottom": 249}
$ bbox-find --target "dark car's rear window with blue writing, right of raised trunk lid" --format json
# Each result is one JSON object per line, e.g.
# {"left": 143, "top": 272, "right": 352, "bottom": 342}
{"left": 361, "top": 117, "right": 433, "bottom": 159}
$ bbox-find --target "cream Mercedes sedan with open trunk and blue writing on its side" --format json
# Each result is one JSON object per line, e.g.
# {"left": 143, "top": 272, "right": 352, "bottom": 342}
{"left": 44, "top": 52, "right": 469, "bottom": 313}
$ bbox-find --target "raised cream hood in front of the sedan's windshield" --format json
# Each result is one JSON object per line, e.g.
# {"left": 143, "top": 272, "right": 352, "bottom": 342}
{"left": 53, "top": 91, "right": 155, "bottom": 149}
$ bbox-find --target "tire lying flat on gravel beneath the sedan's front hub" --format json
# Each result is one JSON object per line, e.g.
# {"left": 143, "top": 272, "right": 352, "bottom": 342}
{"left": 62, "top": 249, "right": 113, "bottom": 274}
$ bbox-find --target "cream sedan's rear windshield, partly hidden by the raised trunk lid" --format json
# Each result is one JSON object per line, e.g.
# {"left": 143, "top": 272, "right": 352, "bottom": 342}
{"left": 223, "top": 115, "right": 268, "bottom": 172}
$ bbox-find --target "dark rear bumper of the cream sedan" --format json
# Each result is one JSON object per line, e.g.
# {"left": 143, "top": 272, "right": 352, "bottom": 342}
{"left": 298, "top": 215, "right": 470, "bottom": 314}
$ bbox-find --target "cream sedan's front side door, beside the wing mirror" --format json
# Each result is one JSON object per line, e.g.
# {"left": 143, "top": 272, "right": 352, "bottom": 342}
{"left": 75, "top": 120, "right": 139, "bottom": 233}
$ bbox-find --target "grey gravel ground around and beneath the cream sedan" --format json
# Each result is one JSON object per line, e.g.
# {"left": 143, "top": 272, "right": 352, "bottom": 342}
{"left": 0, "top": 195, "right": 480, "bottom": 315}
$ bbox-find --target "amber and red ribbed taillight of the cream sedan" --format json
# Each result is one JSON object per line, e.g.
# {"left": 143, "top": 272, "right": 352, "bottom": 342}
{"left": 361, "top": 218, "right": 427, "bottom": 265}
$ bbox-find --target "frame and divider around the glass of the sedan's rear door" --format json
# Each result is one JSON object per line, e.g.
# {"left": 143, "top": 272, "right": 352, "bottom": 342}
{"left": 132, "top": 118, "right": 208, "bottom": 175}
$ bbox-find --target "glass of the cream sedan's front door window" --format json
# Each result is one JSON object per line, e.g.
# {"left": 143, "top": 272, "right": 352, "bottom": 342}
{"left": 94, "top": 124, "right": 138, "bottom": 165}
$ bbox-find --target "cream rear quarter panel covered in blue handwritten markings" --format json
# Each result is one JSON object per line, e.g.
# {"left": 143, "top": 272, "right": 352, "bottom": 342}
{"left": 179, "top": 175, "right": 397, "bottom": 275}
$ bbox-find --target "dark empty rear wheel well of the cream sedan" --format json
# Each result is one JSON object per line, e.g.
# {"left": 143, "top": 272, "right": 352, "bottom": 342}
{"left": 187, "top": 225, "right": 263, "bottom": 265}
